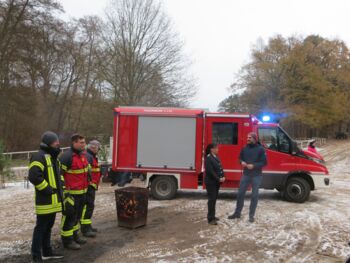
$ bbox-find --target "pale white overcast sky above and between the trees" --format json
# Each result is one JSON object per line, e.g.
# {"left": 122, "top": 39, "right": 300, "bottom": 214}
{"left": 59, "top": 0, "right": 350, "bottom": 111}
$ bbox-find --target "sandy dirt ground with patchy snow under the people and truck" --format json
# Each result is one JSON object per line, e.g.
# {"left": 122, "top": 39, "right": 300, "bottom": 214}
{"left": 0, "top": 141, "right": 350, "bottom": 263}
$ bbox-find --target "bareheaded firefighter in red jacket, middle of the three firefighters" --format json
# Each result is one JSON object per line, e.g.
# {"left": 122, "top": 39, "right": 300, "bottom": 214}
{"left": 60, "top": 134, "right": 89, "bottom": 250}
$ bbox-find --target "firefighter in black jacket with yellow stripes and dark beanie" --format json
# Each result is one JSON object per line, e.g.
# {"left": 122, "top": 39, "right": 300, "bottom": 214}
{"left": 28, "top": 131, "right": 63, "bottom": 262}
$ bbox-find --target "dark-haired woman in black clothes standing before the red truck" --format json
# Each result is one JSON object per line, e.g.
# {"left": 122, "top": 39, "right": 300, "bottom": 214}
{"left": 205, "top": 144, "right": 225, "bottom": 225}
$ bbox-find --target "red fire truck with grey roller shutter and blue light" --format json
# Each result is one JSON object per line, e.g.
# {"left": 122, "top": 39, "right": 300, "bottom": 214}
{"left": 109, "top": 107, "right": 329, "bottom": 203}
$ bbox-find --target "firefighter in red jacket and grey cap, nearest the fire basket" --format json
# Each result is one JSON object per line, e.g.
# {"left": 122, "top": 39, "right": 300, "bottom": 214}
{"left": 80, "top": 140, "right": 101, "bottom": 237}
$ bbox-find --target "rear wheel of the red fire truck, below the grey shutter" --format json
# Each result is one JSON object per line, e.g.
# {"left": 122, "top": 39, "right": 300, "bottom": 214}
{"left": 151, "top": 175, "right": 177, "bottom": 200}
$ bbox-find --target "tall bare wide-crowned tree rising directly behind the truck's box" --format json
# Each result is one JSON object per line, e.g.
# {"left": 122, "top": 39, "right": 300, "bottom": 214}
{"left": 103, "top": 0, "right": 195, "bottom": 108}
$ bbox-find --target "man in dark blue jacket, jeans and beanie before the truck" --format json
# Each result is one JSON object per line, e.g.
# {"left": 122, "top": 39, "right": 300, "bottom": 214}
{"left": 228, "top": 132, "right": 267, "bottom": 223}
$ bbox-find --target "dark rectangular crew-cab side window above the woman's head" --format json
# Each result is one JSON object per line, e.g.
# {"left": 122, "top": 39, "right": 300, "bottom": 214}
{"left": 212, "top": 122, "right": 238, "bottom": 145}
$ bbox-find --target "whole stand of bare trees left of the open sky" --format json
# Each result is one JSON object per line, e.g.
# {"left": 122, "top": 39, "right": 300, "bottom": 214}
{"left": 0, "top": 0, "right": 195, "bottom": 150}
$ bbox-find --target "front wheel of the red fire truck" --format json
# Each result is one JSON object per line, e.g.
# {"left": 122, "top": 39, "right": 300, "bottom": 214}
{"left": 284, "top": 177, "right": 310, "bottom": 203}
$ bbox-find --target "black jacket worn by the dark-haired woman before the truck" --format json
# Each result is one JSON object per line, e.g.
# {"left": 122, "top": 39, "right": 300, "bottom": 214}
{"left": 205, "top": 154, "right": 224, "bottom": 184}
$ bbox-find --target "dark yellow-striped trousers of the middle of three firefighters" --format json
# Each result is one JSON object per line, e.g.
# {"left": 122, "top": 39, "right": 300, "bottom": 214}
{"left": 61, "top": 194, "right": 86, "bottom": 242}
